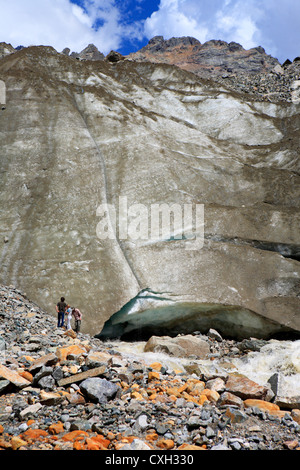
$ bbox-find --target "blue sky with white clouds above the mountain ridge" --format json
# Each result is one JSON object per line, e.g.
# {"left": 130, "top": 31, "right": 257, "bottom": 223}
{"left": 0, "top": 0, "right": 300, "bottom": 62}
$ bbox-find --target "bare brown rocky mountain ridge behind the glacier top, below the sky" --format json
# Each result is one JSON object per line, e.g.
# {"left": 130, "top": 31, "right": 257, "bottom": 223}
{"left": 0, "top": 36, "right": 300, "bottom": 102}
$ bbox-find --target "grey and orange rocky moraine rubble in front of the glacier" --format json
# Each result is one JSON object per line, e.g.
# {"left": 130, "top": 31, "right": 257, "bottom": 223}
{"left": 0, "top": 286, "right": 300, "bottom": 454}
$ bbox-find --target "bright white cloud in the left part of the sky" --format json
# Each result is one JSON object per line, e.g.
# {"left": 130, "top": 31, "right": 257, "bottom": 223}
{"left": 0, "top": 0, "right": 132, "bottom": 54}
